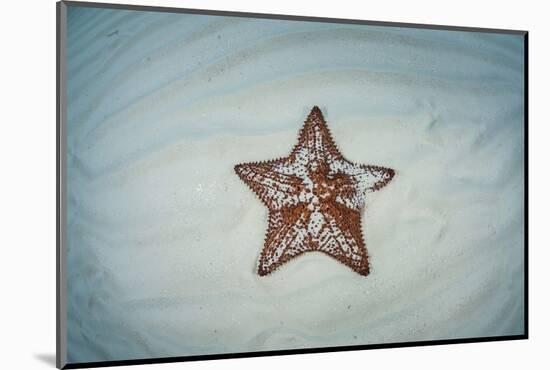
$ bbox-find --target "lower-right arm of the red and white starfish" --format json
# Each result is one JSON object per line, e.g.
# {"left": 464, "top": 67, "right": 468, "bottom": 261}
{"left": 316, "top": 206, "right": 369, "bottom": 276}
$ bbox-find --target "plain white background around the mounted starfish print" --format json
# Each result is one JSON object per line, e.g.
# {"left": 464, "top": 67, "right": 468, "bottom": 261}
{"left": 0, "top": 0, "right": 550, "bottom": 370}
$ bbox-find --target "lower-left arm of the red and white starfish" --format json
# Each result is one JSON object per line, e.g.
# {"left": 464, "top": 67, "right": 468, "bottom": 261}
{"left": 258, "top": 206, "right": 308, "bottom": 276}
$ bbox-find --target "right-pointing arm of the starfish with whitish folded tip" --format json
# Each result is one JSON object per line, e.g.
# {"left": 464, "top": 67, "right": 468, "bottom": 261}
{"left": 331, "top": 159, "right": 395, "bottom": 210}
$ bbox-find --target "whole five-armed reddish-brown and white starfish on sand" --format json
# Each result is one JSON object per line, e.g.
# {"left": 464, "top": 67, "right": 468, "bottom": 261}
{"left": 235, "top": 106, "right": 395, "bottom": 276}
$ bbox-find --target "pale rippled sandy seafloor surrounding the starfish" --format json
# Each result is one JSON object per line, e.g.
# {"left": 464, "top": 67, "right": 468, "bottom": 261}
{"left": 66, "top": 7, "right": 525, "bottom": 362}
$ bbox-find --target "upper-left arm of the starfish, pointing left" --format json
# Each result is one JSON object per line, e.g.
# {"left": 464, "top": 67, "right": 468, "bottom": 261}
{"left": 235, "top": 160, "right": 302, "bottom": 209}
